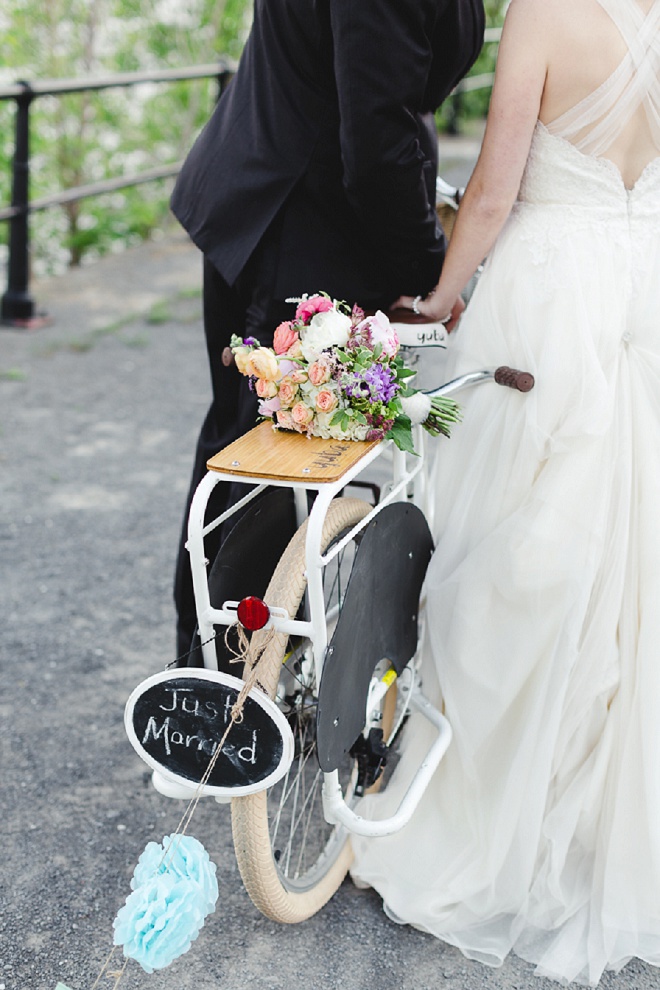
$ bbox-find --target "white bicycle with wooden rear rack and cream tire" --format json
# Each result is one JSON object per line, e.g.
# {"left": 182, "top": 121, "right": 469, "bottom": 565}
{"left": 129, "top": 336, "right": 533, "bottom": 922}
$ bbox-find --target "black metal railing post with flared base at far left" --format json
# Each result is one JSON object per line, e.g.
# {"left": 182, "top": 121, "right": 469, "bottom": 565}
{"left": 0, "top": 81, "right": 44, "bottom": 327}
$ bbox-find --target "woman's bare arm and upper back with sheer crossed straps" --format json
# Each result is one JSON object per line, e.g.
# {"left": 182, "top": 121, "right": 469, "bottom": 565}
{"left": 392, "top": 0, "right": 660, "bottom": 319}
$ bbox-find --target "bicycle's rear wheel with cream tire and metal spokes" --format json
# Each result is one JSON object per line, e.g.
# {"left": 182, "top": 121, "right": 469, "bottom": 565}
{"left": 231, "top": 498, "right": 370, "bottom": 923}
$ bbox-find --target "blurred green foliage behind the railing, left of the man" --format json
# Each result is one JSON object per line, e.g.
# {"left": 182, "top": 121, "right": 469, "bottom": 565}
{"left": 0, "top": 0, "right": 252, "bottom": 274}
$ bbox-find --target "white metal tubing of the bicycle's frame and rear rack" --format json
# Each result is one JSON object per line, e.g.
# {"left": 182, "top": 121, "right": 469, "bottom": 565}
{"left": 187, "top": 371, "right": 502, "bottom": 837}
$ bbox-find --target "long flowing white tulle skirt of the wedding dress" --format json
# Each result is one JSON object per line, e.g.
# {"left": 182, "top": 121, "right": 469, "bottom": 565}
{"left": 353, "top": 200, "right": 660, "bottom": 985}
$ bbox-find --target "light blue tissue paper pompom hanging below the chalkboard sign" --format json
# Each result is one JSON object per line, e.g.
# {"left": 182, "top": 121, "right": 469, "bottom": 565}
{"left": 114, "top": 835, "right": 218, "bottom": 973}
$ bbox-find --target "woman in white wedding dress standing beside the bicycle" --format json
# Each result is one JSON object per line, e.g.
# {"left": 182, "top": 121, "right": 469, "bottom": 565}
{"left": 353, "top": 0, "right": 660, "bottom": 985}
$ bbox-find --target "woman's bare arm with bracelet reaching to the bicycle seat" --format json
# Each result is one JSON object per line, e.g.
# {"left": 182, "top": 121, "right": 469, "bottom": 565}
{"left": 394, "top": 0, "right": 551, "bottom": 320}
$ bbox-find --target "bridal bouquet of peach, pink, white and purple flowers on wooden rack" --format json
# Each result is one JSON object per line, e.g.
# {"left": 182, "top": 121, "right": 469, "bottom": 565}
{"left": 231, "top": 293, "right": 459, "bottom": 452}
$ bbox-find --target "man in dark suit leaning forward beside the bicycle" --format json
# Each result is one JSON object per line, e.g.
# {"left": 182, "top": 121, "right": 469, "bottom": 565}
{"left": 171, "top": 0, "right": 484, "bottom": 654}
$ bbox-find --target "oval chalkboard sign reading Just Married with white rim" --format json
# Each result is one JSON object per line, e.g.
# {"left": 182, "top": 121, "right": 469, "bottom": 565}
{"left": 124, "top": 667, "right": 293, "bottom": 796}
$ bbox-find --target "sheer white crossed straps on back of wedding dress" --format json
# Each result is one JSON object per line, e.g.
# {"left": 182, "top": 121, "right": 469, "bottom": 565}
{"left": 547, "top": 0, "right": 660, "bottom": 156}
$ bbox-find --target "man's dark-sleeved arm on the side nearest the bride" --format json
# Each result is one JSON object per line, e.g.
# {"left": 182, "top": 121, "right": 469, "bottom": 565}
{"left": 330, "top": 0, "right": 452, "bottom": 294}
